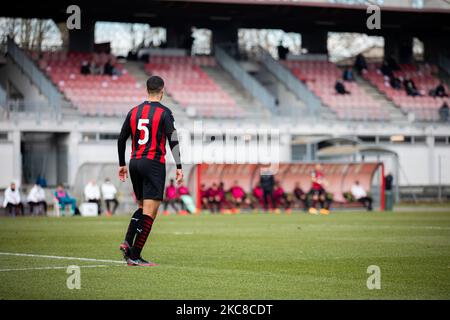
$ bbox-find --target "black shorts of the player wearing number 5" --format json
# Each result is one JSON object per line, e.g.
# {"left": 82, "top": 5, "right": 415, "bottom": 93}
{"left": 129, "top": 158, "right": 166, "bottom": 200}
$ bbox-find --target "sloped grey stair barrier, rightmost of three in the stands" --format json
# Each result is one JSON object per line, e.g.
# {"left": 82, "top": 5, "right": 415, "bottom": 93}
{"left": 259, "top": 47, "right": 322, "bottom": 115}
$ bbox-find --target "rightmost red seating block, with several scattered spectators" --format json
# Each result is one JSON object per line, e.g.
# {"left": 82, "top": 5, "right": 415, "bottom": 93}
{"left": 365, "top": 64, "right": 450, "bottom": 121}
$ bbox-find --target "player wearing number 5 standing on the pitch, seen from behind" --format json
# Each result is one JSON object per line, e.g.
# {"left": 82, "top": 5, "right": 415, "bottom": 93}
{"left": 117, "top": 76, "right": 183, "bottom": 266}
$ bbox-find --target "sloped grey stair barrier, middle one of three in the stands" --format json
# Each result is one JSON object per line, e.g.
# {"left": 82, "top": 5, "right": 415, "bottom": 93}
{"left": 214, "top": 46, "right": 278, "bottom": 114}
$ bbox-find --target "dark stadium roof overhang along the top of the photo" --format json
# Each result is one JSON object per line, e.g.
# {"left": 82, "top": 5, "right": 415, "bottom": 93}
{"left": 2, "top": 0, "right": 450, "bottom": 34}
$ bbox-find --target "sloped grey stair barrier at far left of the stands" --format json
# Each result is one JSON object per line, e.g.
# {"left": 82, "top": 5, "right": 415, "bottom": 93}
{"left": 7, "top": 38, "right": 64, "bottom": 113}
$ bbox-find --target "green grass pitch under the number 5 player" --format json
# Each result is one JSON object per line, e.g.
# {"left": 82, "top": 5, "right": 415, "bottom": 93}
{"left": 0, "top": 210, "right": 450, "bottom": 299}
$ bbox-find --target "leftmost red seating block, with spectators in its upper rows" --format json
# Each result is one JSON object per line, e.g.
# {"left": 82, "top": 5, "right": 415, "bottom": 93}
{"left": 32, "top": 52, "right": 146, "bottom": 116}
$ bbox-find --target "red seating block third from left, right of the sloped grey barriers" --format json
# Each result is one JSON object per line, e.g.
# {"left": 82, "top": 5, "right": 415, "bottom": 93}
{"left": 284, "top": 60, "right": 389, "bottom": 120}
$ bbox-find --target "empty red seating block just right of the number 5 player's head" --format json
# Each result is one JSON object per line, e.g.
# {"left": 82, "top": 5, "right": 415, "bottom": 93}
{"left": 145, "top": 56, "right": 245, "bottom": 118}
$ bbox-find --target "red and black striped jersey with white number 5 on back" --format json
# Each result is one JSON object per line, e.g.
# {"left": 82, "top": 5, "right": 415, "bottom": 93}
{"left": 117, "top": 101, "right": 181, "bottom": 169}
